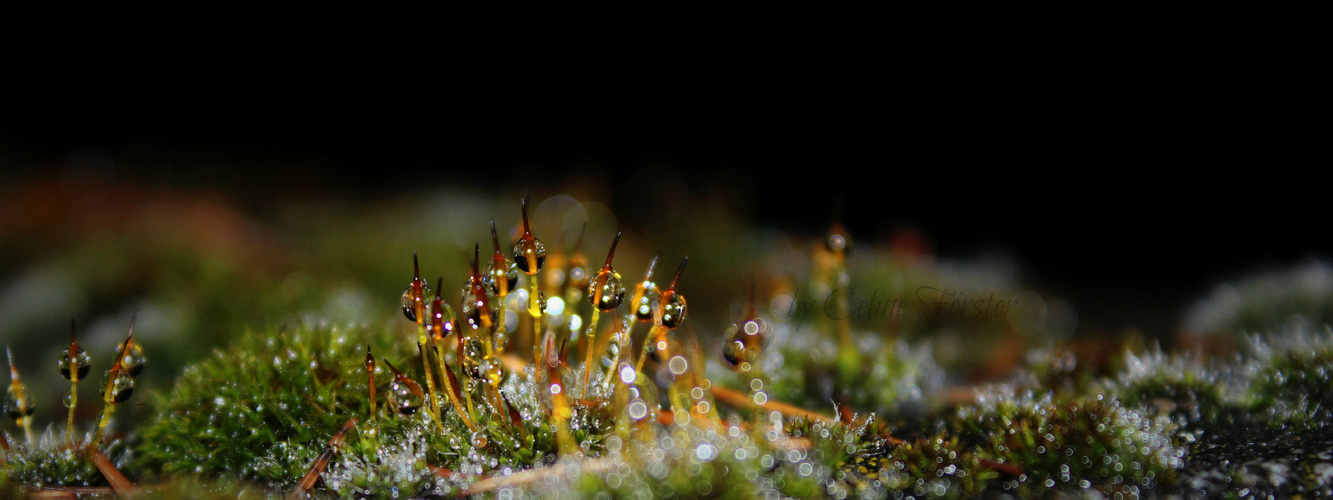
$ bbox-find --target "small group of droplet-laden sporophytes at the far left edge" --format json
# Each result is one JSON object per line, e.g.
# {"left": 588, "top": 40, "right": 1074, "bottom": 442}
{"left": 0, "top": 314, "right": 145, "bottom": 495}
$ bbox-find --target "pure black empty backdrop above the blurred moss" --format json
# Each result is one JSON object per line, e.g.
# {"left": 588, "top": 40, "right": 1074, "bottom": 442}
{"left": 0, "top": 29, "right": 1329, "bottom": 341}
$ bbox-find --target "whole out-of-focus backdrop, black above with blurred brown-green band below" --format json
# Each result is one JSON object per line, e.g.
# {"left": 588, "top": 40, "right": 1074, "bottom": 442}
{"left": 0, "top": 26, "right": 1333, "bottom": 426}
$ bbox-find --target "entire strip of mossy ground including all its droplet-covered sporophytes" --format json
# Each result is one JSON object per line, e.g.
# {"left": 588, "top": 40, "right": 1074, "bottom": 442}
{"left": 0, "top": 200, "right": 1333, "bottom": 499}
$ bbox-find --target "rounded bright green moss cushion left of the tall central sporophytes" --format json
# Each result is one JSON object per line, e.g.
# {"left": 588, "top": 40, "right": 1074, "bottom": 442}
{"left": 139, "top": 322, "right": 387, "bottom": 487}
